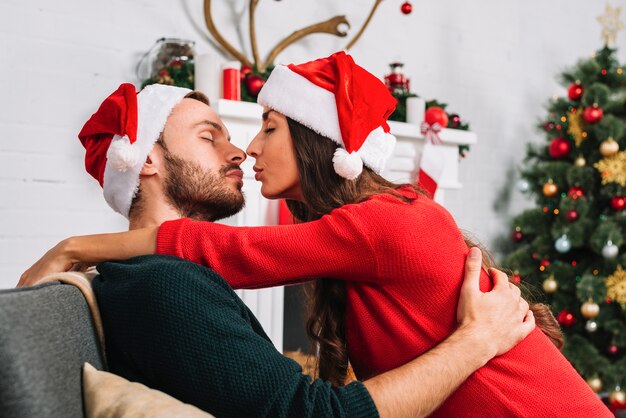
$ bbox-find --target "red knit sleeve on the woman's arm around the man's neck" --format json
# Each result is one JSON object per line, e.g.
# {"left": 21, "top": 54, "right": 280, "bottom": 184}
{"left": 156, "top": 208, "right": 380, "bottom": 289}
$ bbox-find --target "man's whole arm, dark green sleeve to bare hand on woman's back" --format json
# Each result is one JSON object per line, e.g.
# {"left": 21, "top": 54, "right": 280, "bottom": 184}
{"left": 94, "top": 248, "right": 532, "bottom": 417}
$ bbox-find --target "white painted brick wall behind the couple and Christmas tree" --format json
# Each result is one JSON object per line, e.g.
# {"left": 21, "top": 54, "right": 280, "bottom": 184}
{"left": 0, "top": 0, "right": 626, "bottom": 288}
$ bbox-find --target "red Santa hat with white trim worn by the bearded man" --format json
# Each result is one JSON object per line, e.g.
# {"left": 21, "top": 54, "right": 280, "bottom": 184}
{"left": 78, "top": 83, "right": 191, "bottom": 218}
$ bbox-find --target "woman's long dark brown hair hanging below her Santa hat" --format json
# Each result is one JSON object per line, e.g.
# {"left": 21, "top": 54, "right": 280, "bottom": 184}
{"left": 287, "top": 118, "right": 563, "bottom": 386}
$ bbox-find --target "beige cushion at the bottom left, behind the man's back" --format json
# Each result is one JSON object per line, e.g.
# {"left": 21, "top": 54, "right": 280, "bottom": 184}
{"left": 83, "top": 363, "right": 212, "bottom": 418}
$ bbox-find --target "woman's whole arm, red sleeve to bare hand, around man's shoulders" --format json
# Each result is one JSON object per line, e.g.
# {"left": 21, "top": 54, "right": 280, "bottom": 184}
{"left": 18, "top": 201, "right": 377, "bottom": 288}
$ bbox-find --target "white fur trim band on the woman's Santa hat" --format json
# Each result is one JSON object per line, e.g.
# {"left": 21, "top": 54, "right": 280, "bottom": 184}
{"left": 257, "top": 65, "right": 344, "bottom": 146}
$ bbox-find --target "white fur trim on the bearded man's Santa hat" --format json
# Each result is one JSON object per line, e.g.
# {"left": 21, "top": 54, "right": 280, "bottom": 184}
{"left": 103, "top": 84, "right": 191, "bottom": 219}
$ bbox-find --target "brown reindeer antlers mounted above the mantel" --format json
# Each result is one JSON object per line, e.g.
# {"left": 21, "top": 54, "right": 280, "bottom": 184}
{"left": 204, "top": 0, "right": 383, "bottom": 73}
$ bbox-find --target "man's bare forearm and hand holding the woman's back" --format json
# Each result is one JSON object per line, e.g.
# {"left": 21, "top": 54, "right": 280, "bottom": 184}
{"left": 364, "top": 248, "right": 535, "bottom": 417}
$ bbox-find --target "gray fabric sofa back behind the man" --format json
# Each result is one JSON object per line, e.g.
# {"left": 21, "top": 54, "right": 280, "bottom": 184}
{"left": 0, "top": 282, "right": 103, "bottom": 418}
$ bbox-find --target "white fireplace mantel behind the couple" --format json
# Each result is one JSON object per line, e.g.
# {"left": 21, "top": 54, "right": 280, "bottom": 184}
{"left": 212, "top": 99, "right": 477, "bottom": 351}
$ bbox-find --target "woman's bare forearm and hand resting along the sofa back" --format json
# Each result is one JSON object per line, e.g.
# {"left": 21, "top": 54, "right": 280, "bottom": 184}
{"left": 18, "top": 227, "right": 158, "bottom": 287}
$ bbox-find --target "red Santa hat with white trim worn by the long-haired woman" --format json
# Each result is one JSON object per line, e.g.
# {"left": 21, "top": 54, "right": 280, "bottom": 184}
{"left": 258, "top": 52, "right": 397, "bottom": 180}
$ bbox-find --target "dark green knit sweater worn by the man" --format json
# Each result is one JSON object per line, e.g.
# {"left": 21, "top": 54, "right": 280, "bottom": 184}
{"left": 93, "top": 256, "right": 378, "bottom": 418}
